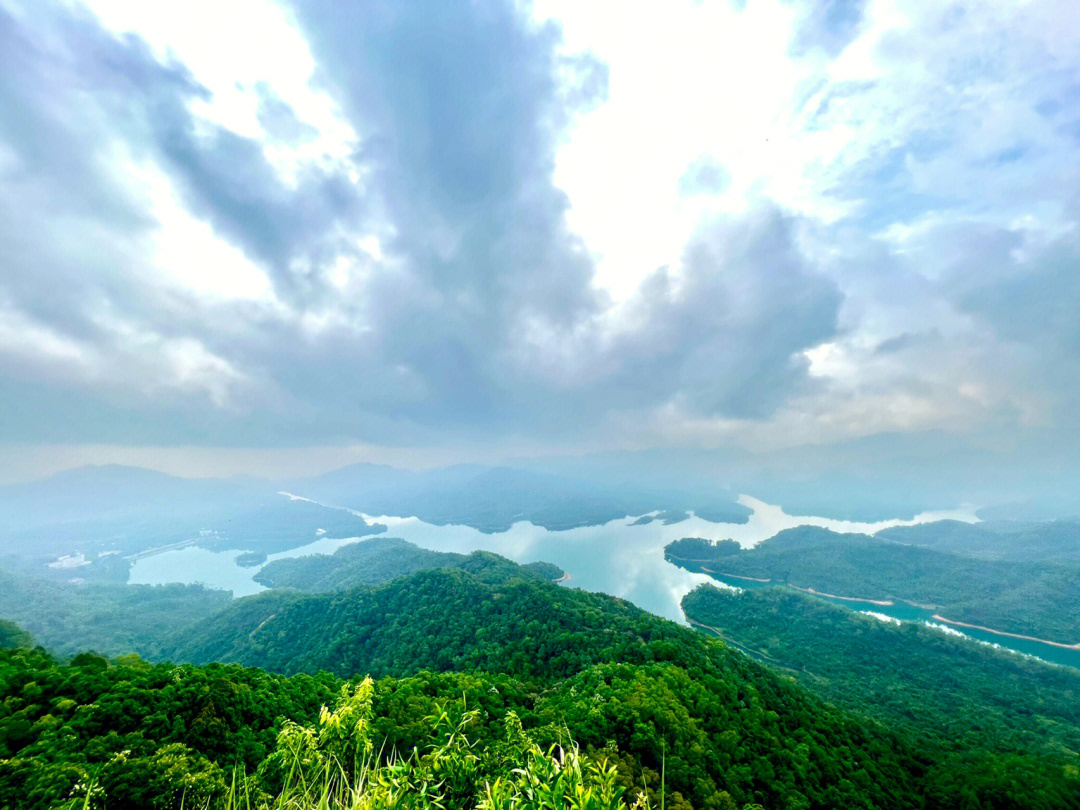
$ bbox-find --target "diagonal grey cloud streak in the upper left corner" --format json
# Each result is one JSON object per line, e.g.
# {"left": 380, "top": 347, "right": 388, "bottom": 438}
{"left": 0, "top": 3, "right": 364, "bottom": 306}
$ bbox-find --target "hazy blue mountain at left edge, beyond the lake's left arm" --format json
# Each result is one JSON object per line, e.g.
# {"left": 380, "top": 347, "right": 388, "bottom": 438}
{"left": 0, "top": 475, "right": 386, "bottom": 583}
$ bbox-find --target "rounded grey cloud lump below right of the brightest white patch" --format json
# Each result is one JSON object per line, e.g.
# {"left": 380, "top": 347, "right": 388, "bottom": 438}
{"left": 596, "top": 210, "right": 842, "bottom": 418}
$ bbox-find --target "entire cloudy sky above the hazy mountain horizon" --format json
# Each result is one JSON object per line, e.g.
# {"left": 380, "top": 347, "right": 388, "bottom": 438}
{"left": 0, "top": 0, "right": 1080, "bottom": 482}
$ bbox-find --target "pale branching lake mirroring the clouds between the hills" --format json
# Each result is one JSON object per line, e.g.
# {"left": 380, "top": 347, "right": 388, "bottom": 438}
{"left": 129, "top": 496, "right": 975, "bottom": 621}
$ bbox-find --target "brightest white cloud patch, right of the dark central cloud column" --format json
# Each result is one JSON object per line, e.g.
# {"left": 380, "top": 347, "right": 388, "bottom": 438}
{"left": 535, "top": 0, "right": 807, "bottom": 300}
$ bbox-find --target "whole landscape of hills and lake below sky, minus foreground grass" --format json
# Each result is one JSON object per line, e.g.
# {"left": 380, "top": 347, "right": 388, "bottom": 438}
{"left": 0, "top": 465, "right": 1080, "bottom": 808}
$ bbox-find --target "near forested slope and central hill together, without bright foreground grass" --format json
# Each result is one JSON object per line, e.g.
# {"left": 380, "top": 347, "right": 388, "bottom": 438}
{"left": 0, "top": 583, "right": 930, "bottom": 810}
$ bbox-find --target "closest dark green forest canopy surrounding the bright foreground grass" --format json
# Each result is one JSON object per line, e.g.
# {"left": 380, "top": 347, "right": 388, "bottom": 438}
{"left": 0, "top": 639, "right": 920, "bottom": 809}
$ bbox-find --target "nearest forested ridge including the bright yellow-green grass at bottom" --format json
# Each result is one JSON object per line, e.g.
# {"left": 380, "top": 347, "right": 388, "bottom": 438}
{"left": 0, "top": 535, "right": 1080, "bottom": 810}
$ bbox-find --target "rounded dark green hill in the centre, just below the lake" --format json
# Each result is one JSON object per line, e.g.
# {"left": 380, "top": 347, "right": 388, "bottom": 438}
{"left": 172, "top": 570, "right": 760, "bottom": 678}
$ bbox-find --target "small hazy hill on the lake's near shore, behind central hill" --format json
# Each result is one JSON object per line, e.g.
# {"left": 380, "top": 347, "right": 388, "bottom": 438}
{"left": 255, "top": 537, "right": 563, "bottom": 592}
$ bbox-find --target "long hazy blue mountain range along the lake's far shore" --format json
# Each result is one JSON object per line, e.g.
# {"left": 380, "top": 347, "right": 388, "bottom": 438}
{"left": 0, "top": 464, "right": 750, "bottom": 559}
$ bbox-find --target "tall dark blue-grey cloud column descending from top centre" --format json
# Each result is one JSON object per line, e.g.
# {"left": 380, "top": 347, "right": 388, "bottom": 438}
{"left": 297, "top": 0, "right": 604, "bottom": 324}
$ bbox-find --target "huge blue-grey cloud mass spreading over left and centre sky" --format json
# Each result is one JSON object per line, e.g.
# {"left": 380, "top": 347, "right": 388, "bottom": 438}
{"left": 0, "top": 0, "right": 840, "bottom": 446}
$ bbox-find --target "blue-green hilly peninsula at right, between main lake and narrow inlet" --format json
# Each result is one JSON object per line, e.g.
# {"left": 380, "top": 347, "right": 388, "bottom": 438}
{"left": 664, "top": 526, "right": 1080, "bottom": 644}
